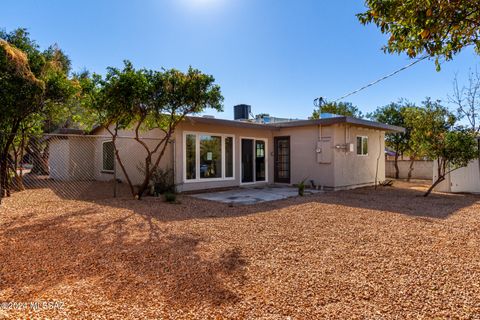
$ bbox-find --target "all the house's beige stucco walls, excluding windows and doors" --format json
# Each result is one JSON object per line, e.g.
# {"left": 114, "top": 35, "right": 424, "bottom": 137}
{"left": 77, "top": 122, "right": 385, "bottom": 192}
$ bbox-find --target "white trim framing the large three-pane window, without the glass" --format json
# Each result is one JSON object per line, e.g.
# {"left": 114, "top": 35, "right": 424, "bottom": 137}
{"left": 182, "top": 131, "right": 236, "bottom": 183}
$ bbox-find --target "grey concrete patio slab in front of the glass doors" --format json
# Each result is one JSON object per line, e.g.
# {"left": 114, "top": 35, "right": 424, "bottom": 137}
{"left": 192, "top": 186, "right": 323, "bottom": 205}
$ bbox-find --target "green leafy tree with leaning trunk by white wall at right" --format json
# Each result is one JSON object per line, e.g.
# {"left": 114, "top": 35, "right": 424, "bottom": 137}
{"left": 412, "top": 99, "right": 477, "bottom": 197}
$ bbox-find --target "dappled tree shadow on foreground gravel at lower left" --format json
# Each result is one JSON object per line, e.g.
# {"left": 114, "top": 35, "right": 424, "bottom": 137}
{"left": 0, "top": 209, "right": 247, "bottom": 308}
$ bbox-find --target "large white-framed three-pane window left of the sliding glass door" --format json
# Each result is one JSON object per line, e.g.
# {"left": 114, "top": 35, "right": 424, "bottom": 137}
{"left": 184, "top": 133, "right": 234, "bottom": 181}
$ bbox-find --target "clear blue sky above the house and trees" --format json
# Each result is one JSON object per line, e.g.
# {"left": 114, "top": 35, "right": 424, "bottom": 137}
{"left": 4, "top": 0, "right": 480, "bottom": 119}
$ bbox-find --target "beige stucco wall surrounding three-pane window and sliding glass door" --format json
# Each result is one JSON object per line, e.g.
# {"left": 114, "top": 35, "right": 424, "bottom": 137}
{"left": 174, "top": 122, "right": 273, "bottom": 192}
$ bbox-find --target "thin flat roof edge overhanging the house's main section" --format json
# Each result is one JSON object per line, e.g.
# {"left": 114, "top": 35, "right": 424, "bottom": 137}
{"left": 186, "top": 116, "right": 405, "bottom": 132}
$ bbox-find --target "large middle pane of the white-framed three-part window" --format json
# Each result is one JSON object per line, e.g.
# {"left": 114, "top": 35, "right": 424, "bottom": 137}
{"left": 200, "top": 136, "right": 222, "bottom": 179}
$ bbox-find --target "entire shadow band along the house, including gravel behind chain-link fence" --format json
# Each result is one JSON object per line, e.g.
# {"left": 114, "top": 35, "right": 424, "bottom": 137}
{"left": 4, "top": 181, "right": 480, "bottom": 221}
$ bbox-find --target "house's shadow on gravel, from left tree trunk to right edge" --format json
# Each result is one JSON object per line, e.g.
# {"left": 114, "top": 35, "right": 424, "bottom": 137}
{"left": 91, "top": 184, "right": 480, "bottom": 221}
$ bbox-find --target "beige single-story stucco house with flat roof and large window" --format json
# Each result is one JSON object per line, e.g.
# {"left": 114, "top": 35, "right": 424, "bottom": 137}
{"left": 49, "top": 110, "right": 404, "bottom": 192}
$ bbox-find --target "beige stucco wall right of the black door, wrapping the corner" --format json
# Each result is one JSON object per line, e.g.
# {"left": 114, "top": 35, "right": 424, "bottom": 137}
{"left": 274, "top": 124, "right": 385, "bottom": 189}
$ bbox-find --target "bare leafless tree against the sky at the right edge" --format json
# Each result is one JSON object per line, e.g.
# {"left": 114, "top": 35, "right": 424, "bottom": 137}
{"left": 449, "top": 69, "right": 480, "bottom": 134}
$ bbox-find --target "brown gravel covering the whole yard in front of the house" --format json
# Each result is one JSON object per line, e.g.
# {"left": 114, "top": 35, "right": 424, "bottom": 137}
{"left": 0, "top": 182, "right": 480, "bottom": 319}
